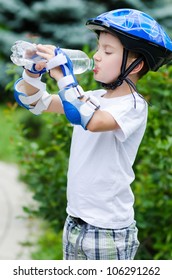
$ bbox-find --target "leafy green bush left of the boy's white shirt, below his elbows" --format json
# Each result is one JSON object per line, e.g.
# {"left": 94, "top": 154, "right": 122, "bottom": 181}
{"left": 18, "top": 112, "right": 71, "bottom": 231}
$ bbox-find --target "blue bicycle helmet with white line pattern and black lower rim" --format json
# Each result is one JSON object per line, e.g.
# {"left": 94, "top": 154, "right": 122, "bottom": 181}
{"left": 86, "top": 9, "right": 172, "bottom": 71}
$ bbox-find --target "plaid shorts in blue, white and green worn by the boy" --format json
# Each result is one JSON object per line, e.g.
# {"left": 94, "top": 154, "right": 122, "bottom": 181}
{"left": 63, "top": 216, "right": 139, "bottom": 260}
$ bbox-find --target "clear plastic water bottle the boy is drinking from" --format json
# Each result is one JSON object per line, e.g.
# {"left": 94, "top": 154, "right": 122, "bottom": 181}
{"left": 10, "top": 41, "right": 93, "bottom": 74}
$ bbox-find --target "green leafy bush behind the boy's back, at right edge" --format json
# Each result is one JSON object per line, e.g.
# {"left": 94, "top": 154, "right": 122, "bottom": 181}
{"left": 133, "top": 66, "right": 172, "bottom": 259}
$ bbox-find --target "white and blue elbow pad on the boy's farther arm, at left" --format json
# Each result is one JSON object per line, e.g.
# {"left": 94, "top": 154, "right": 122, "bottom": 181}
{"left": 14, "top": 71, "right": 52, "bottom": 115}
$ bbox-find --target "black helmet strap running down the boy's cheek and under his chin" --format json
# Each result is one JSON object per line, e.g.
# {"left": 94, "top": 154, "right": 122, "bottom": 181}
{"left": 102, "top": 48, "right": 143, "bottom": 91}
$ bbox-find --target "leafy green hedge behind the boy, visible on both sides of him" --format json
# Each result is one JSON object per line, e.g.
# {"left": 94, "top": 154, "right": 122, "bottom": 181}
{"left": 7, "top": 63, "right": 172, "bottom": 259}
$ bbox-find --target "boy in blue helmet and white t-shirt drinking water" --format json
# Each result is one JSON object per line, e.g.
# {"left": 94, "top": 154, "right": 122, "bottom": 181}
{"left": 12, "top": 9, "right": 172, "bottom": 260}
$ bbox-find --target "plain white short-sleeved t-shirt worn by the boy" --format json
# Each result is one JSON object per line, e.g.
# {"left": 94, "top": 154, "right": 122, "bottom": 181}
{"left": 67, "top": 90, "right": 147, "bottom": 229}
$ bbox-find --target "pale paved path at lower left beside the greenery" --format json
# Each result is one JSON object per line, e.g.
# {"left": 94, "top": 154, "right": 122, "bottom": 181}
{"left": 0, "top": 162, "right": 37, "bottom": 260}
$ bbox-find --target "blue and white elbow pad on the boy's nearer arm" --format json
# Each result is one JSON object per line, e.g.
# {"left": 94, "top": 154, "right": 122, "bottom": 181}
{"left": 59, "top": 86, "right": 100, "bottom": 129}
